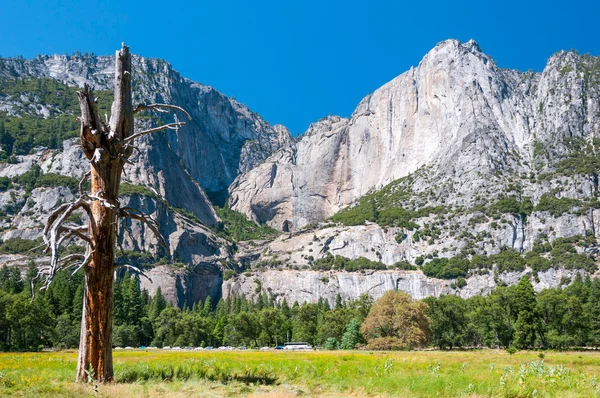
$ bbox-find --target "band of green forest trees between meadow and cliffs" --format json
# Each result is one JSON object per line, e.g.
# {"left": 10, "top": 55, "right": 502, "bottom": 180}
{"left": 0, "top": 262, "right": 600, "bottom": 351}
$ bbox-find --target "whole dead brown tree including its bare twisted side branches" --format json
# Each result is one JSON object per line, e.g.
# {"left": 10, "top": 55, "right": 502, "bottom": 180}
{"left": 40, "top": 45, "right": 189, "bottom": 382}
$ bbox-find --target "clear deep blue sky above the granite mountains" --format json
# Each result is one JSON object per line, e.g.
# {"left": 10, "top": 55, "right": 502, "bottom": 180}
{"left": 0, "top": 0, "right": 600, "bottom": 134}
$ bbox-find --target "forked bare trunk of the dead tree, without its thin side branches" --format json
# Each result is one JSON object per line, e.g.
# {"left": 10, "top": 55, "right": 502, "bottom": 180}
{"left": 77, "top": 46, "right": 133, "bottom": 381}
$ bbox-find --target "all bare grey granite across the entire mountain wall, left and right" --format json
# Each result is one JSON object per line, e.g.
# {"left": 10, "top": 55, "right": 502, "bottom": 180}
{"left": 0, "top": 40, "right": 600, "bottom": 306}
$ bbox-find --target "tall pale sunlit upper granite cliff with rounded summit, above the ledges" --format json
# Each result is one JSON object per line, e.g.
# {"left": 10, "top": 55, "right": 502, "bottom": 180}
{"left": 229, "top": 40, "right": 600, "bottom": 230}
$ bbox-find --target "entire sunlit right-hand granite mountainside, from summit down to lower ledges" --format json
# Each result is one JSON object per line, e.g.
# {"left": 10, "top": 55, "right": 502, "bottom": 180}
{"left": 224, "top": 40, "right": 600, "bottom": 302}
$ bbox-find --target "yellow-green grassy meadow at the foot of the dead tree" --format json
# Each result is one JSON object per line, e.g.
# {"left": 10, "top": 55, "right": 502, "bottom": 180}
{"left": 0, "top": 350, "right": 600, "bottom": 397}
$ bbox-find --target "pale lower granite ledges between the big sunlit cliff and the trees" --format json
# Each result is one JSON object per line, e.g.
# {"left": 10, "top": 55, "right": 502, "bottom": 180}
{"left": 223, "top": 224, "right": 586, "bottom": 305}
